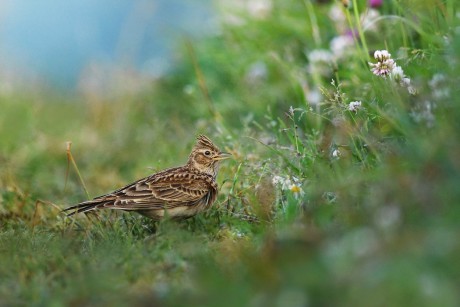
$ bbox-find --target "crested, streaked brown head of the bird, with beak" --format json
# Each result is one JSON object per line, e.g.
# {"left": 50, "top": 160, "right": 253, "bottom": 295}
{"left": 187, "top": 135, "right": 231, "bottom": 177}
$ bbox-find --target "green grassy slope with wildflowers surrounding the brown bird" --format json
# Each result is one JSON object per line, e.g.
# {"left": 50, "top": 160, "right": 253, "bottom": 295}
{"left": 0, "top": 0, "right": 460, "bottom": 306}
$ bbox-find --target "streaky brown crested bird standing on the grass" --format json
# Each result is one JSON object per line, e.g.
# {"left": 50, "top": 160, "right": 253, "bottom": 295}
{"left": 63, "top": 135, "right": 231, "bottom": 221}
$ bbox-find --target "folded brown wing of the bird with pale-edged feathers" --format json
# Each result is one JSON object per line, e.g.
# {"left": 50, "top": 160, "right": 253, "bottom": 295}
{"left": 93, "top": 173, "right": 217, "bottom": 210}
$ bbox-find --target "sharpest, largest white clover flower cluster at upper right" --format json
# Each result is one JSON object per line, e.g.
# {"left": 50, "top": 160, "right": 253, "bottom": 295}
{"left": 369, "top": 50, "right": 416, "bottom": 95}
